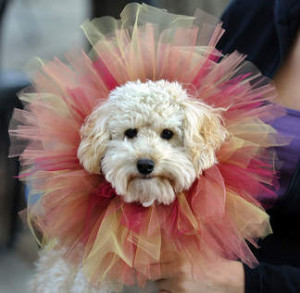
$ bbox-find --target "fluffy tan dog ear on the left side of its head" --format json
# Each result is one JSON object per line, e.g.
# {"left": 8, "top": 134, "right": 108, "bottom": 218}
{"left": 77, "top": 104, "right": 110, "bottom": 174}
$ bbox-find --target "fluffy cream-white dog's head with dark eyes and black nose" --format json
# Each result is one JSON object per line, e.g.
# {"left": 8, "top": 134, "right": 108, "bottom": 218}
{"left": 78, "top": 80, "right": 227, "bottom": 206}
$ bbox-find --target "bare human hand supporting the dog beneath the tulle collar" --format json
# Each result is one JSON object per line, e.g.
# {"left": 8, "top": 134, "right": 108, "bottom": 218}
{"left": 155, "top": 260, "right": 245, "bottom": 293}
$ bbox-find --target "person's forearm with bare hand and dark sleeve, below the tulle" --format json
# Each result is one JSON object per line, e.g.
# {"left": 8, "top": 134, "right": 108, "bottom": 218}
{"left": 156, "top": 261, "right": 300, "bottom": 293}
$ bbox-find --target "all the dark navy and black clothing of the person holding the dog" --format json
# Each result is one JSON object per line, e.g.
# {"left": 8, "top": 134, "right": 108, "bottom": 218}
{"left": 218, "top": 0, "right": 300, "bottom": 293}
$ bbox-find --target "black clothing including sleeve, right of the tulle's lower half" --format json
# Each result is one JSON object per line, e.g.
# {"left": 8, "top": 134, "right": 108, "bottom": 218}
{"left": 244, "top": 163, "right": 300, "bottom": 293}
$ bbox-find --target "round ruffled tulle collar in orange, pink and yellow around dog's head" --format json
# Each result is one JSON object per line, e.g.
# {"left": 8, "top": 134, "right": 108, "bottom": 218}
{"left": 10, "top": 4, "right": 284, "bottom": 286}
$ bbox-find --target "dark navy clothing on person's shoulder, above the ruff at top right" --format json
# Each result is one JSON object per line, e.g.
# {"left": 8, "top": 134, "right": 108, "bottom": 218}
{"left": 218, "top": 0, "right": 300, "bottom": 77}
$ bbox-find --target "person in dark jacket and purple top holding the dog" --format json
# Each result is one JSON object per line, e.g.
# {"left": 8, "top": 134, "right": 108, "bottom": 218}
{"left": 157, "top": 0, "right": 300, "bottom": 293}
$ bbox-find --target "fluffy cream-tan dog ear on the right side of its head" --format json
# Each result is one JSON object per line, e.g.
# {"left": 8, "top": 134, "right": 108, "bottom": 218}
{"left": 184, "top": 100, "right": 228, "bottom": 174}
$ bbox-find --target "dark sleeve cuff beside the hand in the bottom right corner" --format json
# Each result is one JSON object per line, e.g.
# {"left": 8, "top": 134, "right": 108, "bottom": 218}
{"left": 244, "top": 263, "right": 300, "bottom": 293}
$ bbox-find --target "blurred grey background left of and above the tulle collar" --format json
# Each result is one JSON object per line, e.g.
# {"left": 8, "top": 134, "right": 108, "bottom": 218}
{"left": 0, "top": 0, "right": 229, "bottom": 293}
